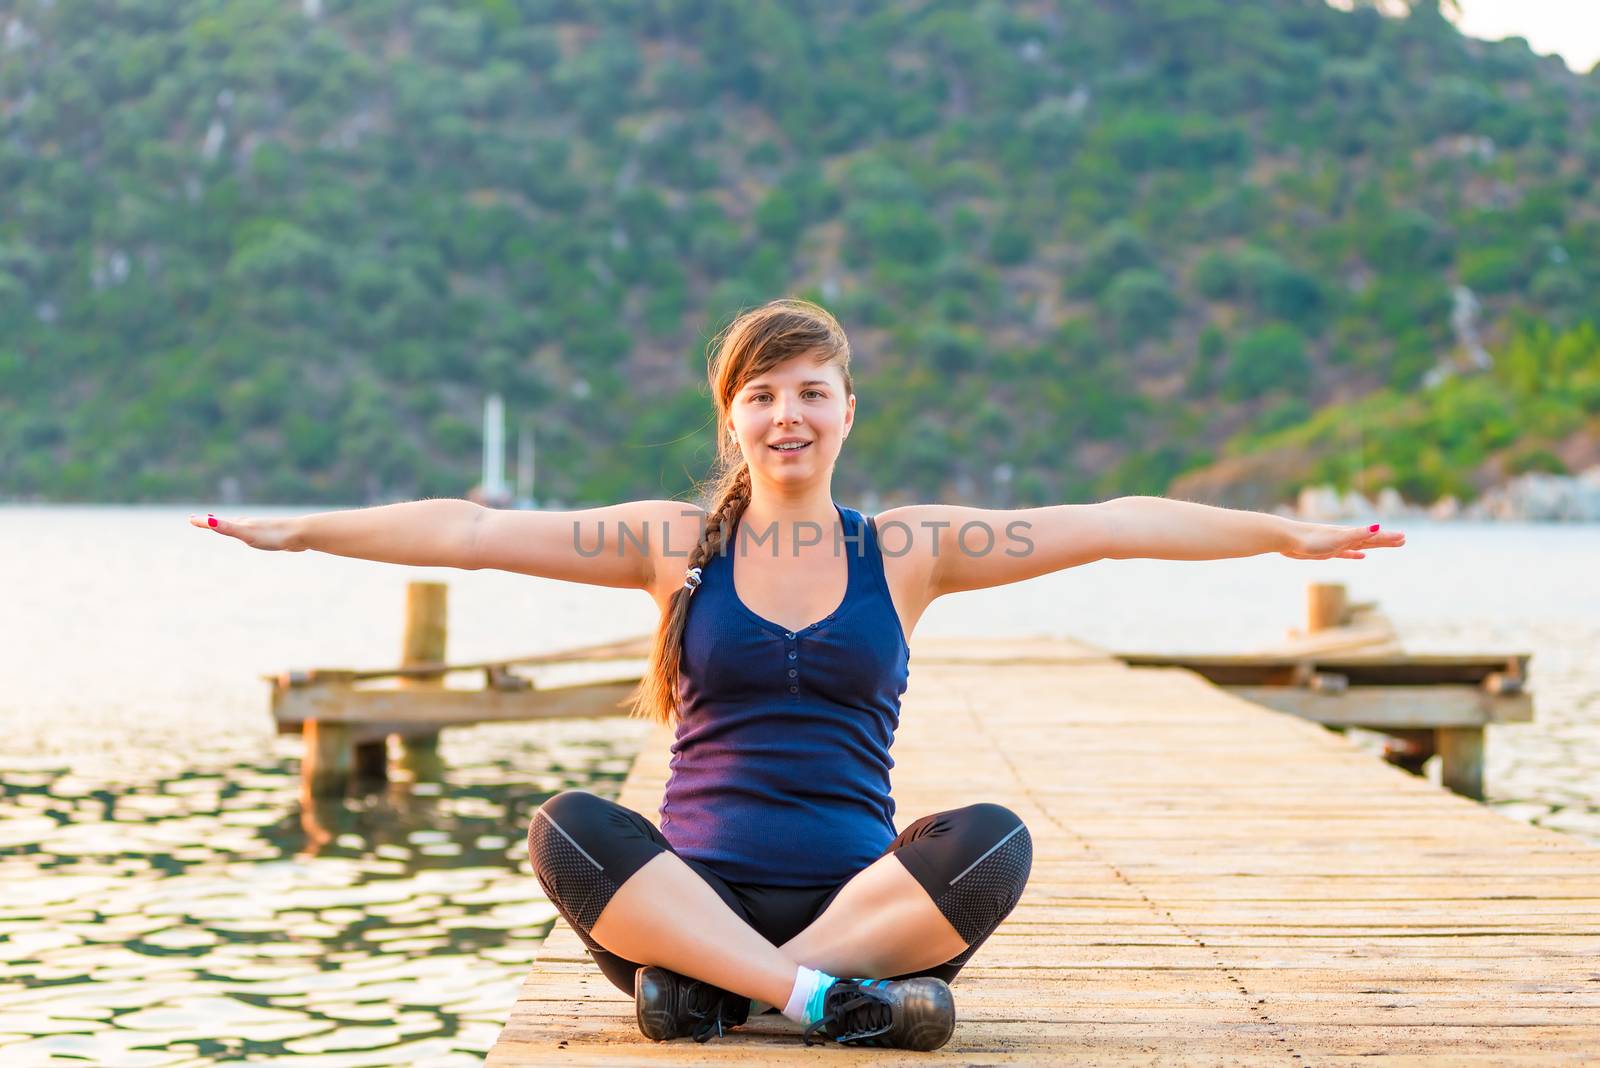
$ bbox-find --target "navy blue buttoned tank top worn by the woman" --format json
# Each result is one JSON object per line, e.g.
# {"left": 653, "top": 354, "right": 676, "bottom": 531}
{"left": 661, "top": 502, "right": 910, "bottom": 886}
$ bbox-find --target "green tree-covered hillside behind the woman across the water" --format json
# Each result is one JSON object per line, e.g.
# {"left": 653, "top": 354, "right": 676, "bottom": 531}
{"left": 0, "top": 0, "right": 1600, "bottom": 504}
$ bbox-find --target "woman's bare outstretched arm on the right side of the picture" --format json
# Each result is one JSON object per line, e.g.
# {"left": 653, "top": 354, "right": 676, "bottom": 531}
{"left": 877, "top": 497, "right": 1405, "bottom": 596}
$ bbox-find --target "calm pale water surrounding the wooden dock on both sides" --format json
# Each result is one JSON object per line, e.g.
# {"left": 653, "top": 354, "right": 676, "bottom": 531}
{"left": 0, "top": 505, "right": 1600, "bottom": 1065}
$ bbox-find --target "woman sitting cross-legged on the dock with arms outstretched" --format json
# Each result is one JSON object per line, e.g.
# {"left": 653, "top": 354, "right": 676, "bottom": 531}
{"left": 192, "top": 301, "right": 1405, "bottom": 1049}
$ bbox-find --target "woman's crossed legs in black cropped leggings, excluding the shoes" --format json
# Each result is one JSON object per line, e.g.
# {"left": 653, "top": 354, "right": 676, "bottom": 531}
{"left": 528, "top": 791, "right": 1032, "bottom": 1004}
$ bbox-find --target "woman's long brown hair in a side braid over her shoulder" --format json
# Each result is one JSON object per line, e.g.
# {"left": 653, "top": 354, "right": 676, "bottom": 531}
{"left": 632, "top": 297, "right": 854, "bottom": 724}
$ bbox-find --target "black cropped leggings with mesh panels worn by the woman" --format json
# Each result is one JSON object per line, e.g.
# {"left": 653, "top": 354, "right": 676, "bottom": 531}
{"left": 528, "top": 790, "right": 1034, "bottom": 996}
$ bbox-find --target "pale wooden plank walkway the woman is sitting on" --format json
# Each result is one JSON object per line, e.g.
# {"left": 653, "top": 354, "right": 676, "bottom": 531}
{"left": 488, "top": 638, "right": 1600, "bottom": 1066}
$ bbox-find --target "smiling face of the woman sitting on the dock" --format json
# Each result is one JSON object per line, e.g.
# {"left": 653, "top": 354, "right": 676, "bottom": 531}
{"left": 723, "top": 357, "right": 856, "bottom": 483}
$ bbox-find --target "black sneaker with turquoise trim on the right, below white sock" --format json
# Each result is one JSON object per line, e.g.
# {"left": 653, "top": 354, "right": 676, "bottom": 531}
{"left": 802, "top": 975, "right": 955, "bottom": 1049}
